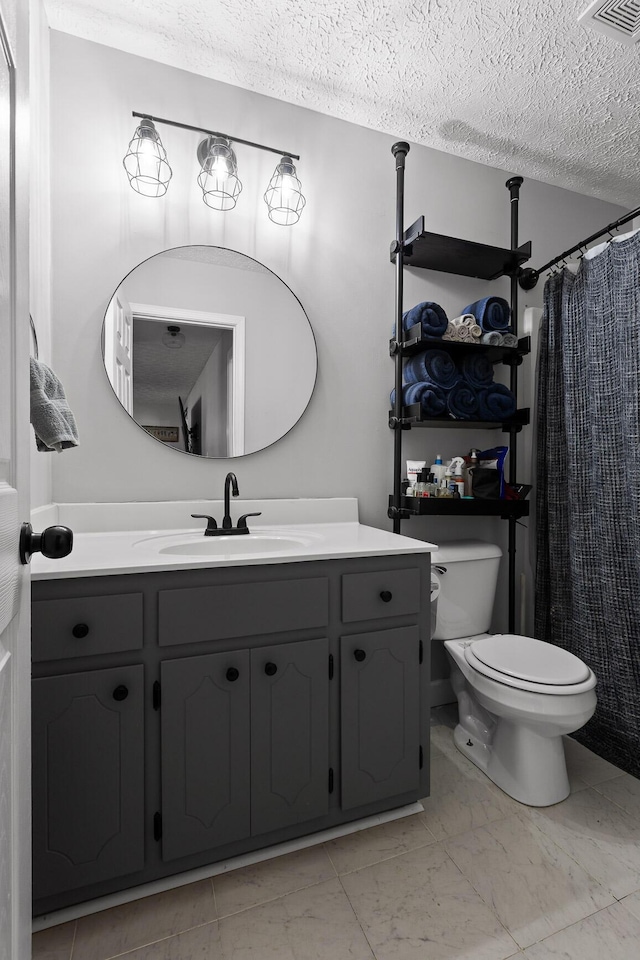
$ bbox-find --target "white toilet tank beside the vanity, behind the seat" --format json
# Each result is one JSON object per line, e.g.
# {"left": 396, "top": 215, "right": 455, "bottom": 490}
{"left": 431, "top": 540, "right": 502, "bottom": 640}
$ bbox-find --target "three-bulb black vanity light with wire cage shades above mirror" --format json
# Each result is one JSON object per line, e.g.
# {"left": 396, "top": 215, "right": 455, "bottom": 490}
{"left": 123, "top": 111, "right": 307, "bottom": 226}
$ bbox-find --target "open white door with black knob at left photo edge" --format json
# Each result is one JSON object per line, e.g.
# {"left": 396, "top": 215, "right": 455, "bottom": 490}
{"left": 0, "top": 0, "right": 31, "bottom": 960}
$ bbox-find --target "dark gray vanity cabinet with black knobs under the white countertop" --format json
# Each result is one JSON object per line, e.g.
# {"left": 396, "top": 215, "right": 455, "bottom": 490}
{"left": 32, "top": 554, "right": 430, "bottom": 915}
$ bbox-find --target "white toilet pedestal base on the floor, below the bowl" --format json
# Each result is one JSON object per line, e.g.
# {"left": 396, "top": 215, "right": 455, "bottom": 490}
{"left": 453, "top": 717, "right": 569, "bottom": 807}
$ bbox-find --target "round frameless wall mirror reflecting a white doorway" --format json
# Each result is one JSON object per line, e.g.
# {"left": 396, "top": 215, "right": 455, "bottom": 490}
{"left": 102, "top": 246, "right": 318, "bottom": 457}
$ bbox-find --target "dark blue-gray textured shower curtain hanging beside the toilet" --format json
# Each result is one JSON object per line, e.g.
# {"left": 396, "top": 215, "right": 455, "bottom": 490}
{"left": 535, "top": 233, "right": 640, "bottom": 776}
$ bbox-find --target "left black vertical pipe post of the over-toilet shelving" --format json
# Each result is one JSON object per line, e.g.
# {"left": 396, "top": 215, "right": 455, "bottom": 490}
{"left": 391, "top": 140, "right": 410, "bottom": 533}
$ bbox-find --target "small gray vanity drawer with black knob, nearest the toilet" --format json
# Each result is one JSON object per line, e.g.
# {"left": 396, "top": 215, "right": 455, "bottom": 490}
{"left": 342, "top": 567, "right": 420, "bottom": 623}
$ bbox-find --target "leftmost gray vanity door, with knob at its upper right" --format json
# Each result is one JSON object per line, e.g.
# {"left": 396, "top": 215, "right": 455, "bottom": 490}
{"left": 32, "top": 666, "right": 144, "bottom": 900}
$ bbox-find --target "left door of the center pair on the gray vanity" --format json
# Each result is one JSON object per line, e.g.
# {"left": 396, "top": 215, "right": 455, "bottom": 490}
{"left": 161, "top": 650, "right": 250, "bottom": 860}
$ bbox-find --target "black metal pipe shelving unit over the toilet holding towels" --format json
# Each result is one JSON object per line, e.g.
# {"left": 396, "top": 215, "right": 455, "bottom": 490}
{"left": 388, "top": 142, "right": 531, "bottom": 633}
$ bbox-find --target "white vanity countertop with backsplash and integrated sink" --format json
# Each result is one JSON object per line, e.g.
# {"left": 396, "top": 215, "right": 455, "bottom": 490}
{"left": 31, "top": 499, "right": 436, "bottom": 580}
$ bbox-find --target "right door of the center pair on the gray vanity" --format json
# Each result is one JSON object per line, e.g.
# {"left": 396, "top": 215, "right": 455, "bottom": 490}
{"left": 251, "top": 639, "right": 329, "bottom": 834}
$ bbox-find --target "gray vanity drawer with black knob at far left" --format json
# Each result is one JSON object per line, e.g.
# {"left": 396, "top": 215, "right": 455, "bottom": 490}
{"left": 31, "top": 593, "right": 142, "bottom": 662}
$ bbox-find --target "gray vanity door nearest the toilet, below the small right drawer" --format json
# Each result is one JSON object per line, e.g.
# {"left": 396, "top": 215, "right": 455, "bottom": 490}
{"left": 340, "top": 627, "right": 420, "bottom": 809}
